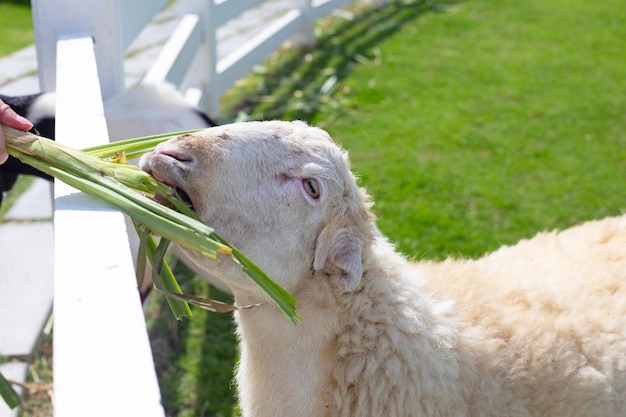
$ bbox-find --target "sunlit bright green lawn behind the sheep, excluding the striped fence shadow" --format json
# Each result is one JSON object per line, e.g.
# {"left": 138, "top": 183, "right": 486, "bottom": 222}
{"left": 326, "top": 0, "right": 626, "bottom": 257}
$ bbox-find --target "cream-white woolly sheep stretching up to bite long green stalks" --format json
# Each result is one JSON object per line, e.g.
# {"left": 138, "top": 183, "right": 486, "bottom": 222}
{"left": 141, "top": 121, "right": 626, "bottom": 417}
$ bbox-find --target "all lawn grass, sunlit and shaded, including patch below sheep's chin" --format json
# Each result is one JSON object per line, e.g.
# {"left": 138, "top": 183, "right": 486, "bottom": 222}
{"left": 0, "top": 0, "right": 626, "bottom": 416}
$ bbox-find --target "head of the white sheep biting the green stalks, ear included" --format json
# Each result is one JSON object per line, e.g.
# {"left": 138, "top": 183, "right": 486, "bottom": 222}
{"left": 140, "top": 121, "right": 373, "bottom": 298}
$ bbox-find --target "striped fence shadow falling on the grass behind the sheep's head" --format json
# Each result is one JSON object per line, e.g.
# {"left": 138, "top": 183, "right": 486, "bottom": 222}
{"left": 223, "top": 0, "right": 459, "bottom": 122}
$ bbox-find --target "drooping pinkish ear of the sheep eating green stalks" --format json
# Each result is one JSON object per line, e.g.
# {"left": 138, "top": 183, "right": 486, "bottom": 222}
{"left": 313, "top": 225, "right": 363, "bottom": 291}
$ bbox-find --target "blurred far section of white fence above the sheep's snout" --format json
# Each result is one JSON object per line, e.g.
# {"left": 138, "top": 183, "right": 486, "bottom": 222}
{"left": 144, "top": 0, "right": 376, "bottom": 118}
